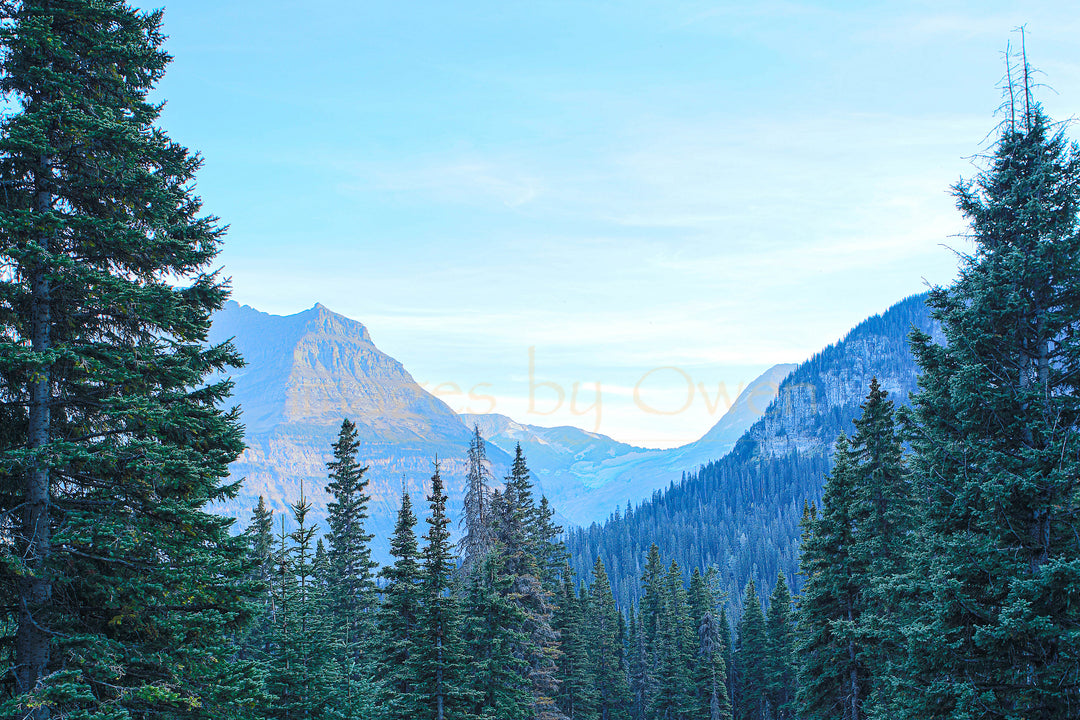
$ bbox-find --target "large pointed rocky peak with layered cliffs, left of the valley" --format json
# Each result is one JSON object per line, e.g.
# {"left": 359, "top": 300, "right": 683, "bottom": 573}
{"left": 211, "top": 302, "right": 509, "bottom": 557}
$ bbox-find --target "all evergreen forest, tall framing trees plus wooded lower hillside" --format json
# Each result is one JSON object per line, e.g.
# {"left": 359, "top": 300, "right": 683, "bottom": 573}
{"left": 0, "top": 0, "right": 1080, "bottom": 720}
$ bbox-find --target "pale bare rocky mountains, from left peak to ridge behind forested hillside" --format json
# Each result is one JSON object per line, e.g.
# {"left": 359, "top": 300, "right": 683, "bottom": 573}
{"left": 211, "top": 302, "right": 791, "bottom": 559}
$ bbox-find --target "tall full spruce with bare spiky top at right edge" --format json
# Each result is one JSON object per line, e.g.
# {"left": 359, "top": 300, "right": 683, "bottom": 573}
{"left": 907, "top": 49, "right": 1080, "bottom": 720}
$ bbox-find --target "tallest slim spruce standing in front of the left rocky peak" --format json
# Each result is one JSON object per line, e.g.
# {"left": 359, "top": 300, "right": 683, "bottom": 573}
{"left": 326, "top": 419, "right": 378, "bottom": 716}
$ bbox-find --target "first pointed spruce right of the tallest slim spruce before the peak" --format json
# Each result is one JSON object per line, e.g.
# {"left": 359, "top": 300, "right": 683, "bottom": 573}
{"left": 379, "top": 489, "right": 421, "bottom": 720}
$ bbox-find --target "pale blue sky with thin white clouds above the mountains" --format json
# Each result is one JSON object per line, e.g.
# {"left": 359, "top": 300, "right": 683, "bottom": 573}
{"left": 150, "top": 0, "right": 1080, "bottom": 446}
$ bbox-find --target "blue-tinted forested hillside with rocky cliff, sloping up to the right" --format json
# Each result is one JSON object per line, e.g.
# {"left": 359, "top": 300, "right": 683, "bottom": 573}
{"left": 567, "top": 295, "right": 940, "bottom": 610}
